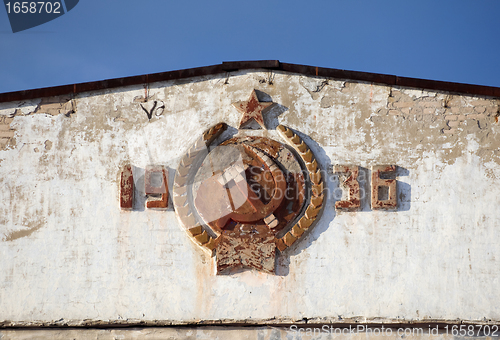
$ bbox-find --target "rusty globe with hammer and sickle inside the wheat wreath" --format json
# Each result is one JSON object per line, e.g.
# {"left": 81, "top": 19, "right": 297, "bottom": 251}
{"left": 196, "top": 144, "right": 287, "bottom": 230}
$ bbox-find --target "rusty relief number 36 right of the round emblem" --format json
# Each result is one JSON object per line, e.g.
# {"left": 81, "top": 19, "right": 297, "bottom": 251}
{"left": 333, "top": 165, "right": 398, "bottom": 211}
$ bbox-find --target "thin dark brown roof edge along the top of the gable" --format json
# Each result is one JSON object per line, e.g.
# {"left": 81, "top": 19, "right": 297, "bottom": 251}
{"left": 0, "top": 60, "right": 500, "bottom": 103}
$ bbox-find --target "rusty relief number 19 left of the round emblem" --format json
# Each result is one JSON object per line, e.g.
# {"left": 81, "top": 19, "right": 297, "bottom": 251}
{"left": 120, "top": 165, "right": 168, "bottom": 210}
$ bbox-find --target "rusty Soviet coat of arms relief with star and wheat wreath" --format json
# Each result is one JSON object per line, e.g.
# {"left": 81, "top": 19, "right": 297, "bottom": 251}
{"left": 172, "top": 90, "right": 325, "bottom": 274}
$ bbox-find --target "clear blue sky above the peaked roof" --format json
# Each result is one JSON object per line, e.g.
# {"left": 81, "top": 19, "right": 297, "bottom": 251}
{"left": 0, "top": 0, "right": 500, "bottom": 93}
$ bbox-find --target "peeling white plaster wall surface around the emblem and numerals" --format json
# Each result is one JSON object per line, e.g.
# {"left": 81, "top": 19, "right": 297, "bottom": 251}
{"left": 0, "top": 70, "right": 500, "bottom": 325}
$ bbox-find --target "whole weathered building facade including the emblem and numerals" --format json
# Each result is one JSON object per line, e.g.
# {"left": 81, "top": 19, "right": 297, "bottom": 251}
{"left": 0, "top": 61, "right": 500, "bottom": 339}
